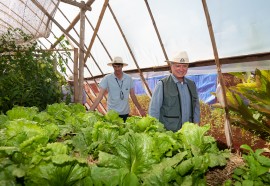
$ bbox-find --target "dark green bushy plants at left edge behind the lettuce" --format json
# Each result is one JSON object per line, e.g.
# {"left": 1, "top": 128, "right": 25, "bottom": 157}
{"left": 0, "top": 29, "right": 63, "bottom": 113}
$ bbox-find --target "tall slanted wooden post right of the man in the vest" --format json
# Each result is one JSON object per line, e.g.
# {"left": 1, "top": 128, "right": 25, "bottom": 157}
{"left": 202, "top": 0, "right": 232, "bottom": 148}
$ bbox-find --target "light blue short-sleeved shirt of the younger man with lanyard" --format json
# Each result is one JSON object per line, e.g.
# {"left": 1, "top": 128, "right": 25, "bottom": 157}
{"left": 99, "top": 73, "right": 134, "bottom": 115}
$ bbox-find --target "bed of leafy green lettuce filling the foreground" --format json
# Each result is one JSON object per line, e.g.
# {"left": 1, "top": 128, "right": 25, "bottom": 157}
{"left": 0, "top": 103, "right": 270, "bottom": 186}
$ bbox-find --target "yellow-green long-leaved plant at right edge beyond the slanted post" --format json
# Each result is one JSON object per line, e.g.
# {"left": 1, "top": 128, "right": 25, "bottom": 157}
{"left": 226, "top": 69, "right": 270, "bottom": 139}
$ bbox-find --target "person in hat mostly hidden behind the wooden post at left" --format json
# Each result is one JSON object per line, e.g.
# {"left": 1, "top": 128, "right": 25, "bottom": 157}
{"left": 62, "top": 75, "right": 86, "bottom": 105}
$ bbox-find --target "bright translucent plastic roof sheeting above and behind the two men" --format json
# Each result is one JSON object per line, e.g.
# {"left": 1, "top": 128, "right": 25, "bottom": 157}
{"left": 42, "top": 0, "right": 270, "bottom": 76}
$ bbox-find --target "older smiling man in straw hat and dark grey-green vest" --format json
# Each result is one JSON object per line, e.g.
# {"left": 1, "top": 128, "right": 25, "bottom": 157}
{"left": 149, "top": 51, "right": 200, "bottom": 132}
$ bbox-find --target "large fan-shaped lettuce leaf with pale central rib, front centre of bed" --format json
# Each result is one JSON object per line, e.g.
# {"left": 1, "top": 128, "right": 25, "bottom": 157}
{"left": 99, "top": 133, "right": 156, "bottom": 175}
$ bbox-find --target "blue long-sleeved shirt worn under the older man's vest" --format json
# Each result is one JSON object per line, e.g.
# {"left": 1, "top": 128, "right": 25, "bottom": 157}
{"left": 148, "top": 75, "right": 200, "bottom": 124}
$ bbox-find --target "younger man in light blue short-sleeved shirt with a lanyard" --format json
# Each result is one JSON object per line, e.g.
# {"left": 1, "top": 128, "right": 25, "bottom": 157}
{"left": 90, "top": 57, "right": 146, "bottom": 122}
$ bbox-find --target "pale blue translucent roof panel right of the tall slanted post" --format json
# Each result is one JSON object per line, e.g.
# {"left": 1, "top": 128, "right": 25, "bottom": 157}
{"left": 207, "top": 0, "right": 270, "bottom": 57}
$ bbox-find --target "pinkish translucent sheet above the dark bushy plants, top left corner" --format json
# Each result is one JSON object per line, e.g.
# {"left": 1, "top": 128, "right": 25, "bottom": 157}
{"left": 0, "top": 0, "right": 59, "bottom": 38}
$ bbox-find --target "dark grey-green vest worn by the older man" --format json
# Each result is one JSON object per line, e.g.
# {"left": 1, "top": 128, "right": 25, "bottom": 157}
{"left": 159, "top": 75, "right": 198, "bottom": 132}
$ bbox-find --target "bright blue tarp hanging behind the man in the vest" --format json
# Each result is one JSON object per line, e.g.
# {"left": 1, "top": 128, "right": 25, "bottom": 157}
{"left": 134, "top": 74, "right": 217, "bottom": 104}
